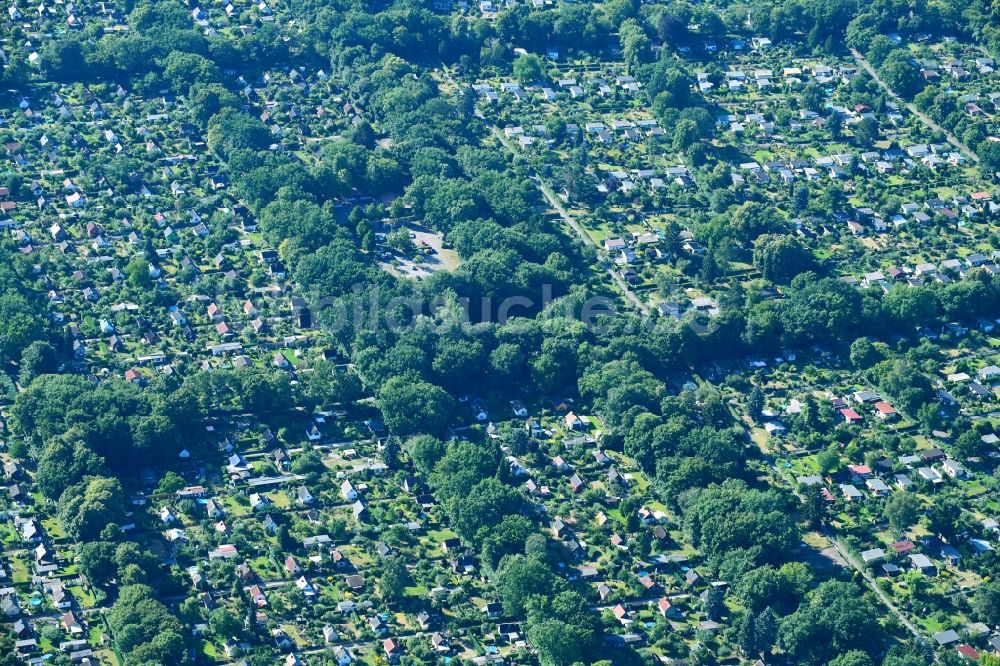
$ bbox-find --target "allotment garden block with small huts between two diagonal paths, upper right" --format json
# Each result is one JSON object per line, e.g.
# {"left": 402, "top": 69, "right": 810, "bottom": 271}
{"left": 471, "top": 39, "right": 997, "bottom": 322}
